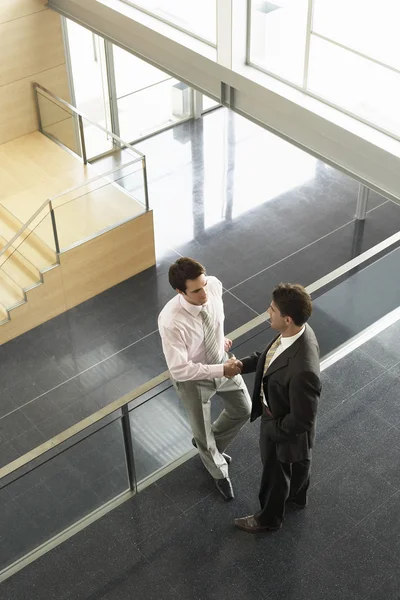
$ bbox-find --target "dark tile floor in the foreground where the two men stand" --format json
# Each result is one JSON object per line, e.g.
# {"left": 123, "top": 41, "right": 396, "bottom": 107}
{"left": 0, "top": 321, "right": 400, "bottom": 600}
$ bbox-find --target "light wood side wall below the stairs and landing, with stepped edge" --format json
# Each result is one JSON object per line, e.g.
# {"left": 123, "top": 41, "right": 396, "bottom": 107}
{"left": 0, "top": 211, "right": 155, "bottom": 344}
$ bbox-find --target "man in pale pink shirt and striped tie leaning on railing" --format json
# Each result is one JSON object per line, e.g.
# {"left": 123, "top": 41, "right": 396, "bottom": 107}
{"left": 158, "top": 258, "right": 251, "bottom": 500}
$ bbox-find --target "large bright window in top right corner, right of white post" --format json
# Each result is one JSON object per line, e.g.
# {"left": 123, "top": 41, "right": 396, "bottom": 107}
{"left": 247, "top": 0, "right": 400, "bottom": 137}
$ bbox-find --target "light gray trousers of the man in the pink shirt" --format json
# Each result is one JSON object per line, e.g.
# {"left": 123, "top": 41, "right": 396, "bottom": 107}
{"left": 173, "top": 375, "right": 251, "bottom": 479}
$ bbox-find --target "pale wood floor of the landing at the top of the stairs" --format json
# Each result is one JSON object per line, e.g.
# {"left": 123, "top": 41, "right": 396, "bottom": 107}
{"left": 0, "top": 132, "right": 144, "bottom": 252}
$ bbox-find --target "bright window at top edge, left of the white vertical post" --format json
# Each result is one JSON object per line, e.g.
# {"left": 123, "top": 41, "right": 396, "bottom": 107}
{"left": 125, "top": 0, "right": 217, "bottom": 45}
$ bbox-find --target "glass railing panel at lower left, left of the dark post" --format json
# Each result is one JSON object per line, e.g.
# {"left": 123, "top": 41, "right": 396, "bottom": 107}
{"left": 0, "top": 417, "right": 129, "bottom": 570}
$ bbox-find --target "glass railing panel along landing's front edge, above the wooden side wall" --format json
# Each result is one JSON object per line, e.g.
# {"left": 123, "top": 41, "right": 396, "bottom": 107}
{"left": 52, "top": 161, "right": 146, "bottom": 250}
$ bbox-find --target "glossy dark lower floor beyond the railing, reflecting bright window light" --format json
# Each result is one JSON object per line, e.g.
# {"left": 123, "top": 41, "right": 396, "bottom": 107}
{"left": 0, "top": 109, "right": 400, "bottom": 464}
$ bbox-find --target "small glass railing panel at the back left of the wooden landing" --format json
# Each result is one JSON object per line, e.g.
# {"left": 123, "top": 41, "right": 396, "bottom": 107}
{"left": 37, "top": 89, "right": 82, "bottom": 156}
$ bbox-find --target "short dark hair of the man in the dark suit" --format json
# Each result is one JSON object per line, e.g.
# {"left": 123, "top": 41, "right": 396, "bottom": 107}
{"left": 272, "top": 283, "right": 312, "bottom": 327}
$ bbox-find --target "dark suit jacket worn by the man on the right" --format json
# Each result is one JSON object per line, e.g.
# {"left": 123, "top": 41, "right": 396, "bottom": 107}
{"left": 241, "top": 324, "right": 321, "bottom": 463}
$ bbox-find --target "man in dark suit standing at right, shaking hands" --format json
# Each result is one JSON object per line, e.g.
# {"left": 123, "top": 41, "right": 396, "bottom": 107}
{"left": 235, "top": 283, "right": 321, "bottom": 533}
